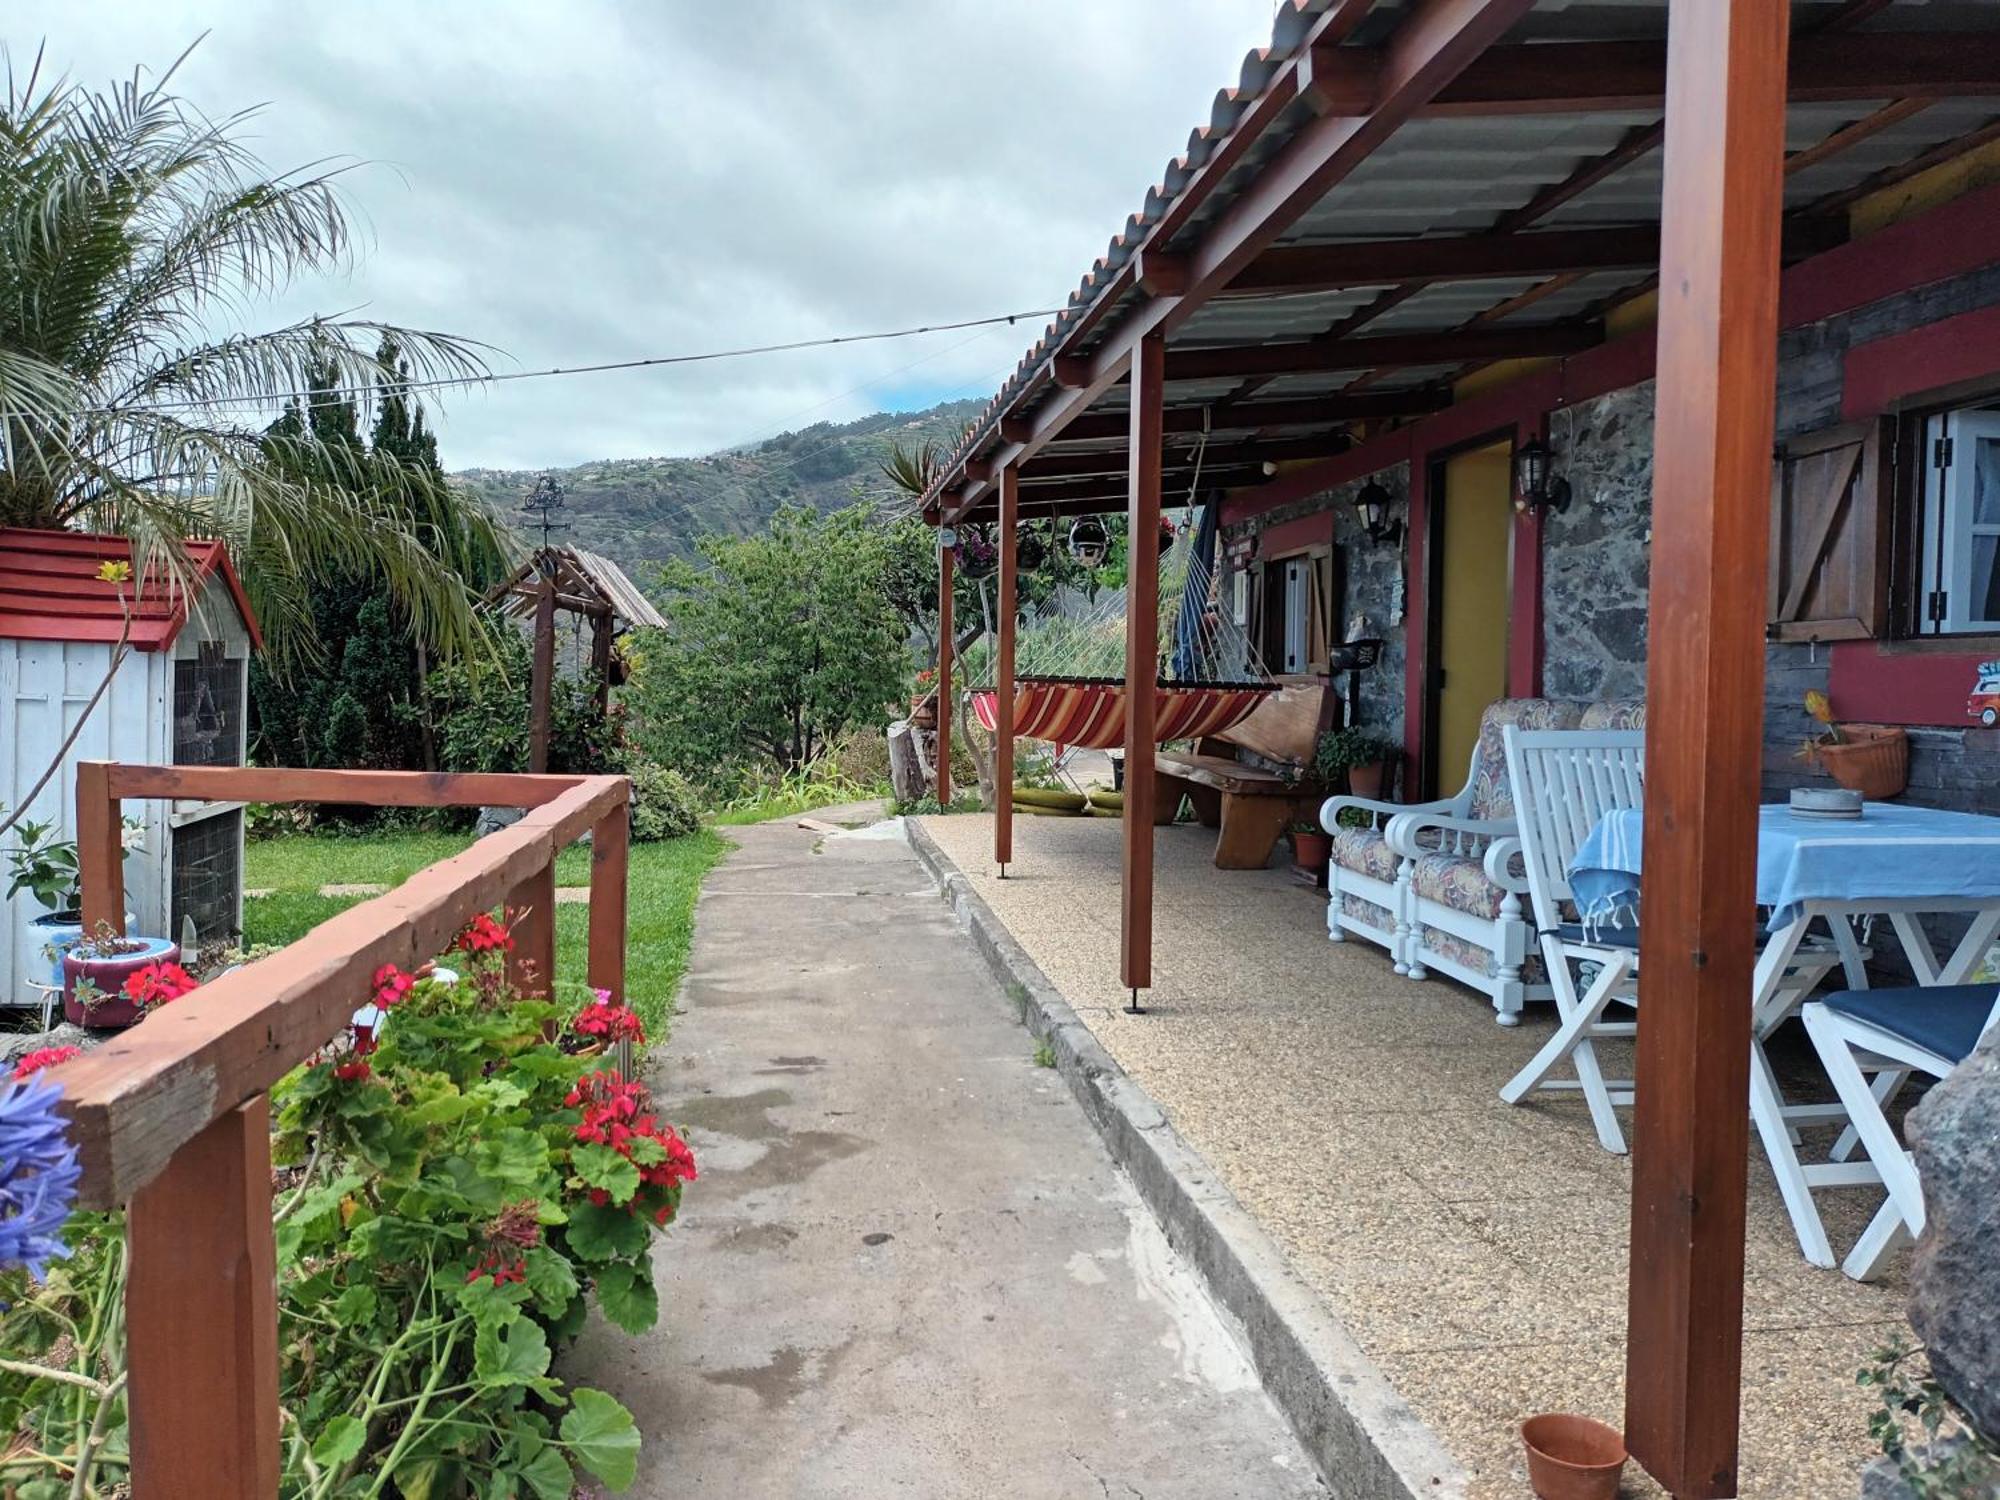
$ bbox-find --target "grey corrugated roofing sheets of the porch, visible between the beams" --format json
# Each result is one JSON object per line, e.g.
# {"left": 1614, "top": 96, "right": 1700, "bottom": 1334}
{"left": 946, "top": 0, "right": 2000, "bottom": 516}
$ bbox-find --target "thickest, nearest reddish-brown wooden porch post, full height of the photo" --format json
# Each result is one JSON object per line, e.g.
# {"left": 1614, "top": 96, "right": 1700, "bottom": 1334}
{"left": 1626, "top": 0, "right": 1788, "bottom": 1500}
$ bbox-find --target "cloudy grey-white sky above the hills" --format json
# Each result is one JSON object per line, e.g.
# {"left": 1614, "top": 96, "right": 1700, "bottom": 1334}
{"left": 15, "top": 0, "right": 1272, "bottom": 468}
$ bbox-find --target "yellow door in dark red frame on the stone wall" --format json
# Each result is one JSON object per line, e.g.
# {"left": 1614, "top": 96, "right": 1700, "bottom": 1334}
{"left": 1434, "top": 442, "right": 1514, "bottom": 796}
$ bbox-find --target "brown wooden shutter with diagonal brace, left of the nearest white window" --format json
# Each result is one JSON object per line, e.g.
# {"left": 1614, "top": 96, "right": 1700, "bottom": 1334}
{"left": 1768, "top": 418, "right": 1894, "bottom": 640}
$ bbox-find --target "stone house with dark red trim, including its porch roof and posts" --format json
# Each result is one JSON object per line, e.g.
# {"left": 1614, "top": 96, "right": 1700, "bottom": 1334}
{"left": 926, "top": 0, "right": 2000, "bottom": 1496}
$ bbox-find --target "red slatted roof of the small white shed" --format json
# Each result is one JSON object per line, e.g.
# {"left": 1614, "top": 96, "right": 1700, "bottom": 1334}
{"left": 0, "top": 526, "right": 264, "bottom": 652}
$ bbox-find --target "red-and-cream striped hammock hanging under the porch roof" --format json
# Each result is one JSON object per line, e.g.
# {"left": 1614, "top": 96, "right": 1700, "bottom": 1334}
{"left": 972, "top": 482, "right": 1278, "bottom": 750}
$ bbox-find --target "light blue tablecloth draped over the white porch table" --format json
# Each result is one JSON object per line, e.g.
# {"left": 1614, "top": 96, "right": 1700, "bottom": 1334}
{"left": 1570, "top": 802, "right": 2000, "bottom": 928}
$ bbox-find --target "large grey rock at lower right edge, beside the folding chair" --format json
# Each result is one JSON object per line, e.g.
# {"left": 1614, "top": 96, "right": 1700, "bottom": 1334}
{"left": 1906, "top": 1030, "right": 2000, "bottom": 1432}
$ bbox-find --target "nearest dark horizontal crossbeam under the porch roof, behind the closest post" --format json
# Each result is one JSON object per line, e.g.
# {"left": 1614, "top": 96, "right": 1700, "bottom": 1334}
{"left": 1314, "top": 30, "right": 2000, "bottom": 116}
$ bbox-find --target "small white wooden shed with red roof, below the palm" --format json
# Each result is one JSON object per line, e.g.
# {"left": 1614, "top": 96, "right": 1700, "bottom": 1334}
{"left": 0, "top": 528, "right": 262, "bottom": 1004}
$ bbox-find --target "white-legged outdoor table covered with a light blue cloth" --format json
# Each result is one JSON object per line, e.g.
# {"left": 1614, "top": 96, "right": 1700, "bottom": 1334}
{"left": 1570, "top": 802, "right": 2000, "bottom": 1266}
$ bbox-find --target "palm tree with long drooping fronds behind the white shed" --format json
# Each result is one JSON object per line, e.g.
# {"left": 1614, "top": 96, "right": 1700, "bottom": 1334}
{"left": 0, "top": 44, "right": 504, "bottom": 666}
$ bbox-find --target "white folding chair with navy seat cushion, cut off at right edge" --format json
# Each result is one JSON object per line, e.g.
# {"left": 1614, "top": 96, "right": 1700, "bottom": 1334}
{"left": 1800, "top": 984, "right": 2000, "bottom": 1282}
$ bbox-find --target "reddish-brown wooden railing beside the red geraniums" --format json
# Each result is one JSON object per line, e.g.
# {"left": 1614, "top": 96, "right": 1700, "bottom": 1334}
{"left": 60, "top": 762, "right": 630, "bottom": 1500}
